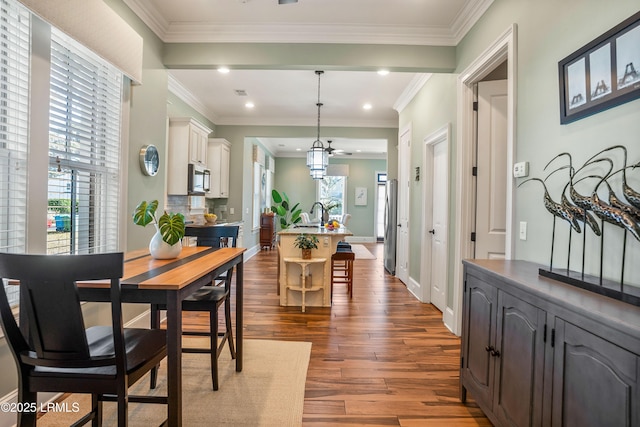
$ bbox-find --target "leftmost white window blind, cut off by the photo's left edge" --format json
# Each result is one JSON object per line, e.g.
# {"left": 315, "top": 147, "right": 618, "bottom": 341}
{"left": 0, "top": 0, "right": 30, "bottom": 304}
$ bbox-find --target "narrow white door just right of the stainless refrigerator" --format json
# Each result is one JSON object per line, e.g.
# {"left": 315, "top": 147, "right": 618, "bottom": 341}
{"left": 396, "top": 126, "right": 411, "bottom": 285}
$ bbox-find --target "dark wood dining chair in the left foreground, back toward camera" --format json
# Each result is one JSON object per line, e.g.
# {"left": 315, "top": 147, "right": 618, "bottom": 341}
{"left": 0, "top": 253, "right": 167, "bottom": 427}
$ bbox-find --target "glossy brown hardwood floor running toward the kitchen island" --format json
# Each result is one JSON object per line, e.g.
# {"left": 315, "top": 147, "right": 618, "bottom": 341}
{"left": 184, "top": 244, "right": 491, "bottom": 427}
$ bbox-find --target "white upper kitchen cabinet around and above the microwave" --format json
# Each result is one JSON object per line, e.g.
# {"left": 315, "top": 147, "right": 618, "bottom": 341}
{"left": 167, "top": 117, "right": 211, "bottom": 195}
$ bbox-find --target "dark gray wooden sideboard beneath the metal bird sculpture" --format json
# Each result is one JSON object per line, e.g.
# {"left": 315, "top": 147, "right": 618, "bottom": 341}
{"left": 460, "top": 260, "right": 640, "bottom": 427}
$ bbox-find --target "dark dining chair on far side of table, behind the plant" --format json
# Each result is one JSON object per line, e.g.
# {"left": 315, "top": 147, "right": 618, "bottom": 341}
{"left": 151, "top": 225, "right": 240, "bottom": 390}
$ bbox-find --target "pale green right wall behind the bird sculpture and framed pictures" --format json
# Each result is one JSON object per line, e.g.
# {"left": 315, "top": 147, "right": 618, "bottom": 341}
{"left": 399, "top": 0, "right": 640, "bottom": 307}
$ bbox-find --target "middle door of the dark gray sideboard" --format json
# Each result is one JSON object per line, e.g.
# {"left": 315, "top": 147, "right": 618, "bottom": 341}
{"left": 493, "top": 292, "right": 546, "bottom": 427}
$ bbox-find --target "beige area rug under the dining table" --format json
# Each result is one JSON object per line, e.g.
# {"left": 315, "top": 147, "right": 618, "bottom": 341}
{"left": 38, "top": 337, "right": 311, "bottom": 427}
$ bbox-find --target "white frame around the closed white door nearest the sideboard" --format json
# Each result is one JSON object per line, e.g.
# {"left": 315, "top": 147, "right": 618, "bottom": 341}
{"left": 420, "top": 123, "right": 453, "bottom": 314}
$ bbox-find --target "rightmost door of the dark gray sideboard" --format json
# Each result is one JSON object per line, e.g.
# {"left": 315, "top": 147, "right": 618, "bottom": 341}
{"left": 552, "top": 320, "right": 640, "bottom": 427}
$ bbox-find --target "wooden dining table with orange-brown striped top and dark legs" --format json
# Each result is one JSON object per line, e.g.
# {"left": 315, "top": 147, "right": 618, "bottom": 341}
{"left": 78, "top": 246, "right": 246, "bottom": 426}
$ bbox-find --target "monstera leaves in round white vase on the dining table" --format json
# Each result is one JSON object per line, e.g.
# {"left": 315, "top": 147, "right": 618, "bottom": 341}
{"left": 133, "top": 200, "right": 185, "bottom": 259}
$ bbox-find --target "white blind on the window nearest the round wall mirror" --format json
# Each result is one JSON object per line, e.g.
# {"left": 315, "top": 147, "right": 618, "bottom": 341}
{"left": 47, "top": 29, "right": 122, "bottom": 254}
